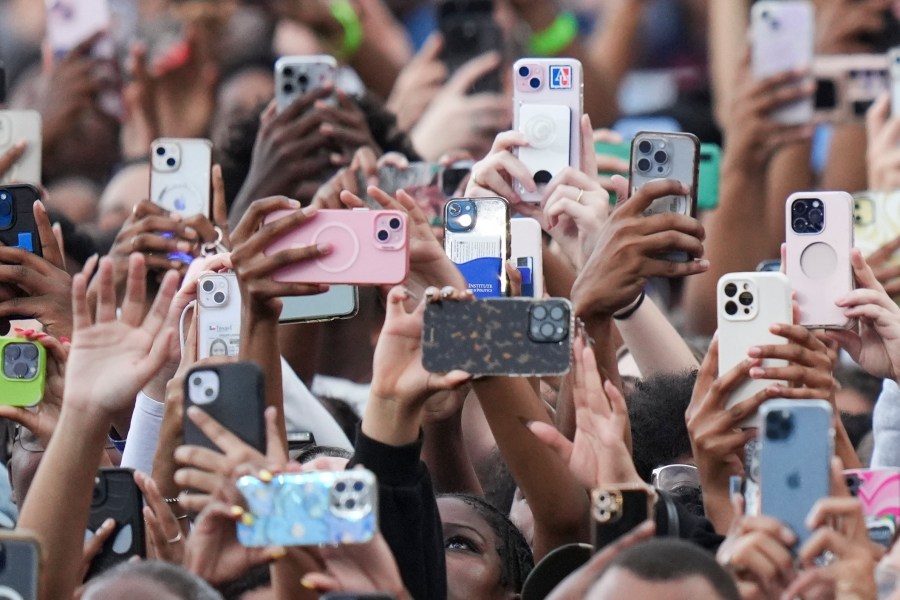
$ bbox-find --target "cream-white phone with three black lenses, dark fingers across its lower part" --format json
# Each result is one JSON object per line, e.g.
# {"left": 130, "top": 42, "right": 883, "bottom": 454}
{"left": 716, "top": 272, "right": 793, "bottom": 427}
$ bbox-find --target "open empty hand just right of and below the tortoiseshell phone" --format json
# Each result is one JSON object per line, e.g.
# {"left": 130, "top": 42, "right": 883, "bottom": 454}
{"left": 528, "top": 338, "right": 642, "bottom": 489}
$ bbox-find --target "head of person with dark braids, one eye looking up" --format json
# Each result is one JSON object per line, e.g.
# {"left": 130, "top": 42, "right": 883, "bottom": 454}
{"left": 438, "top": 494, "right": 534, "bottom": 600}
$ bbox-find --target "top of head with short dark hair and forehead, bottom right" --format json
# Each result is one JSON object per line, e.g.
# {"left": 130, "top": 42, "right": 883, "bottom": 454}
{"left": 585, "top": 538, "right": 740, "bottom": 600}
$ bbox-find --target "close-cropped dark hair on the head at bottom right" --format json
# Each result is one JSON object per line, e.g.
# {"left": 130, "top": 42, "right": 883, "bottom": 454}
{"left": 598, "top": 538, "right": 741, "bottom": 600}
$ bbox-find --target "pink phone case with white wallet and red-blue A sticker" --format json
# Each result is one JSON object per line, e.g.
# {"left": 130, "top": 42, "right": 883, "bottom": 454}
{"left": 513, "top": 58, "right": 584, "bottom": 202}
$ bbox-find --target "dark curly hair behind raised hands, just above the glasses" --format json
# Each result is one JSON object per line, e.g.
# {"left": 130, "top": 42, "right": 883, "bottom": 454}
{"left": 627, "top": 371, "right": 697, "bottom": 482}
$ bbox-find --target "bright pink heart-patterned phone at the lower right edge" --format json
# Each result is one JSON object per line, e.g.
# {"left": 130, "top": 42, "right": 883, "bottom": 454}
{"left": 844, "top": 469, "right": 900, "bottom": 548}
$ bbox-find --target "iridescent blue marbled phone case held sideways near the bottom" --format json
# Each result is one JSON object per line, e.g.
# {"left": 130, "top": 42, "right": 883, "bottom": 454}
{"left": 237, "top": 469, "right": 378, "bottom": 546}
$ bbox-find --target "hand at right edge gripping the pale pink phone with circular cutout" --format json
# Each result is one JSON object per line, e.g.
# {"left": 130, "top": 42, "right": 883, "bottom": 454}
{"left": 826, "top": 249, "right": 900, "bottom": 380}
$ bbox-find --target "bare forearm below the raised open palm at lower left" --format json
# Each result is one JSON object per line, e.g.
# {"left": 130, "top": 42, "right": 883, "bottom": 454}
{"left": 18, "top": 402, "right": 110, "bottom": 600}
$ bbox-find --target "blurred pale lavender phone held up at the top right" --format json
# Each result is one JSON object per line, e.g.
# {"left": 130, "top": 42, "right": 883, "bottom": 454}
{"left": 750, "top": 0, "right": 815, "bottom": 125}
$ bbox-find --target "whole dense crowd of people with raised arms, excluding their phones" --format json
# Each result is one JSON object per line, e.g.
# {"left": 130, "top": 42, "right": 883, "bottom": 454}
{"left": 0, "top": 0, "right": 900, "bottom": 600}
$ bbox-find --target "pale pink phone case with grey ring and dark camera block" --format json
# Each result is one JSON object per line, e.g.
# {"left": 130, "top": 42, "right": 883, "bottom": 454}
{"left": 785, "top": 192, "right": 854, "bottom": 329}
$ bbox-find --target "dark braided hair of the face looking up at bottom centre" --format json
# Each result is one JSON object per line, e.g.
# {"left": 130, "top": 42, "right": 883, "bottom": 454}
{"left": 438, "top": 494, "right": 534, "bottom": 594}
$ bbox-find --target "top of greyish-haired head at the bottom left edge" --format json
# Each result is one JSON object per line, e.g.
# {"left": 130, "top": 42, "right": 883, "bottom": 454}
{"left": 81, "top": 560, "right": 222, "bottom": 600}
